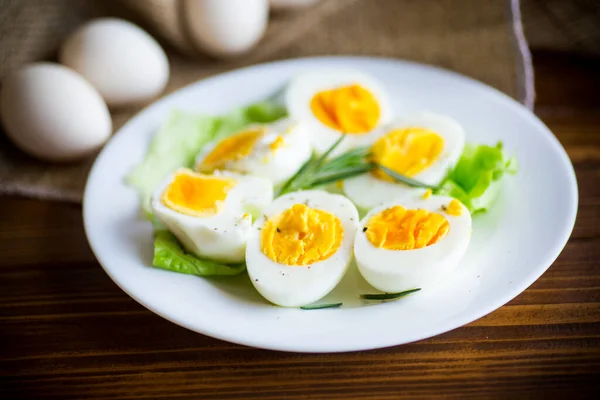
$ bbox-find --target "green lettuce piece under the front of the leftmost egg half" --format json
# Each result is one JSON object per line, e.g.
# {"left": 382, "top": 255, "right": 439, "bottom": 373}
{"left": 152, "top": 230, "right": 246, "bottom": 276}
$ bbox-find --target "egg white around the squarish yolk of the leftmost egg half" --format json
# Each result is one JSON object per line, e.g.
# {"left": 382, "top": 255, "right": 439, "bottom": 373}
{"left": 152, "top": 172, "right": 273, "bottom": 263}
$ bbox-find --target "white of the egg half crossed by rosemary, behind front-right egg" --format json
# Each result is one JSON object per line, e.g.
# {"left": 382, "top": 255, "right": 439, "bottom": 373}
{"left": 343, "top": 111, "right": 465, "bottom": 210}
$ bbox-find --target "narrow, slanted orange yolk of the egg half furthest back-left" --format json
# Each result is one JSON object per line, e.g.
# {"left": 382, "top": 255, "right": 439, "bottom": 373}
{"left": 198, "top": 128, "right": 265, "bottom": 172}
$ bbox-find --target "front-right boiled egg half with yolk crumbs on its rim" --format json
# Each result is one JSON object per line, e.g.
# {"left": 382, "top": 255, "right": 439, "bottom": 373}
{"left": 354, "top": 190, "right": 471, "bottom": 292}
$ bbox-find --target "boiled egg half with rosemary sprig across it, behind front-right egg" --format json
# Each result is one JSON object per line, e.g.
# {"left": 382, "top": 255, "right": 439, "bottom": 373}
{"left": 343, "top": 112, "right": 465, "bottom": 210}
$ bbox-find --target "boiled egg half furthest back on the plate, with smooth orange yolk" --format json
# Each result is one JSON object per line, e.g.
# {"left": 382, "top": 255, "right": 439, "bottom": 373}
{"left": 285, "top": 70, "right": 391, "bottom": 153}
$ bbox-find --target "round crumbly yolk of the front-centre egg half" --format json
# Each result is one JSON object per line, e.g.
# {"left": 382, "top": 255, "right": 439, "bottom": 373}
{"left": 261, "top": 204, "right": 344, "bottom": 266}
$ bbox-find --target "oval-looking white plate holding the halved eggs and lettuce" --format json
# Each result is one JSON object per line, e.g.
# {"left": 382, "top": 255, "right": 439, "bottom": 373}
{"left": 83, "top": 57, "right": 578, "bottom": 352}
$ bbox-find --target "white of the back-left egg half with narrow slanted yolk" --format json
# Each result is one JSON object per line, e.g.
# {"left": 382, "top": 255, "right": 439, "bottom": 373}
{"left": 196, "top": 118, "right": 312, "bottom": 185}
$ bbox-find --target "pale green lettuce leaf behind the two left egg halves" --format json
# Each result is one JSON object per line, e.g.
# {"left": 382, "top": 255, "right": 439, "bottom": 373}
{"left": 125, "top": 102, "right": 286, "bottom": 219}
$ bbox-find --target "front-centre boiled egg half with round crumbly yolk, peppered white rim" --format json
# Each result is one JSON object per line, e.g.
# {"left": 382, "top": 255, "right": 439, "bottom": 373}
{"left": 246, "top": 190, "right": 358, "bottom": 307}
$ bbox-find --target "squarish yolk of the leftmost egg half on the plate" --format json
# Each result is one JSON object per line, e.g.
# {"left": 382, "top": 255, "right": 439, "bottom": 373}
{"left": 161, "top": 170, "right": 237, "bottom": 217}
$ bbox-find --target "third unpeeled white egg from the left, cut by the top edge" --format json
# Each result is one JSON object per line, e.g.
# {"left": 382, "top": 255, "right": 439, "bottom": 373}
{"left": 184, "top": 0, "right": 269, "bottom": 57}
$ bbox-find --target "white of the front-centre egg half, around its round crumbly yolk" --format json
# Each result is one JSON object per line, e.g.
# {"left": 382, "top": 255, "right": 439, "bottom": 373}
{"left": 246, "top": 190, "right": 358, "bottom": 307}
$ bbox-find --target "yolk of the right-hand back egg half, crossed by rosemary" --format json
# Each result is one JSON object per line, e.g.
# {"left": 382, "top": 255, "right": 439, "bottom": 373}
{"left": 371, "top": 128, "right": 444, "bottom": 181}
